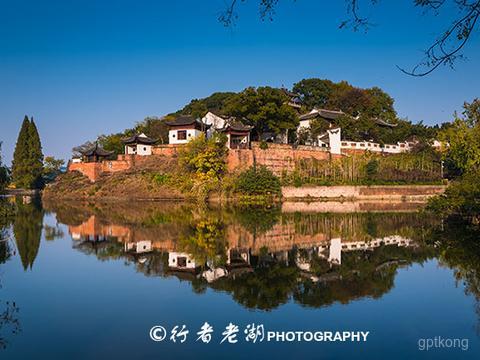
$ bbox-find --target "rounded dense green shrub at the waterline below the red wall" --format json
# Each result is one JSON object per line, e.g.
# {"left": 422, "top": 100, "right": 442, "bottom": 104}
{"left": 235, "top": 166, "right": 281, "bottom": 195}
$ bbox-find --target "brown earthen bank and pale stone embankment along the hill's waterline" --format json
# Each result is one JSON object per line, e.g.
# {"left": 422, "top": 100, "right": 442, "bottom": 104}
{"left": 43, "top": 172, "right": 446, "bottom": 203}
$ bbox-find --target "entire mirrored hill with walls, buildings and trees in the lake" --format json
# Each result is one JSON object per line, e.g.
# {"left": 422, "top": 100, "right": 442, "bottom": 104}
{"left": 45, "top": 203, "right": 436, "bottom": 310}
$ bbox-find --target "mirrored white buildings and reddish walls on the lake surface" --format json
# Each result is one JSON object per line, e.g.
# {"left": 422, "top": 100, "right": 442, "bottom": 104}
{"left": 69, "top": 215, "right": 420, "bottom": 282}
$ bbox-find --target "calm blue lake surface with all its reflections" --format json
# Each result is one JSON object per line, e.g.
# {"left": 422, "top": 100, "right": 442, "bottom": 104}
{"left": 0, "top": 198, "right": 480, "bottom": 359}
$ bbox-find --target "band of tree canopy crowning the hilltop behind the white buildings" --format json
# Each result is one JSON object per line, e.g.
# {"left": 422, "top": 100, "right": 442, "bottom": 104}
{"left": 78, "top": 78, "right": 439, "bottom": 151}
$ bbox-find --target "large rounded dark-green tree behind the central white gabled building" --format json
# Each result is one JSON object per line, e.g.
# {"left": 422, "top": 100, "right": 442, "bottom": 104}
{"left": 225, "top": 86, "right": 298, "bottom": 138}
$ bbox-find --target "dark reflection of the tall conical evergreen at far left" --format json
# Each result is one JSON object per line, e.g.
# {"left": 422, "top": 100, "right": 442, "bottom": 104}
{"left": 13, "top": 199, "right": 43, "bottom": 270}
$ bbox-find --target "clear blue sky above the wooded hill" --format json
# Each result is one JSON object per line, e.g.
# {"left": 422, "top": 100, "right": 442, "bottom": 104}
{"left": 0, "top": 0, "right": 480, "bottom": 164}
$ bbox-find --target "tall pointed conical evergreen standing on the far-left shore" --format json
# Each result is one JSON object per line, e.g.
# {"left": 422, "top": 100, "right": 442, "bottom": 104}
{"left": 12, "top": 116, "right": 43, "bottom": 189}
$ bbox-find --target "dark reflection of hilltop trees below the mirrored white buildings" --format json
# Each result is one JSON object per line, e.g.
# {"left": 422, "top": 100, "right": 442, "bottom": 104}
{"left": 211, "top": 245, "right": 434, "bottom": 310}
